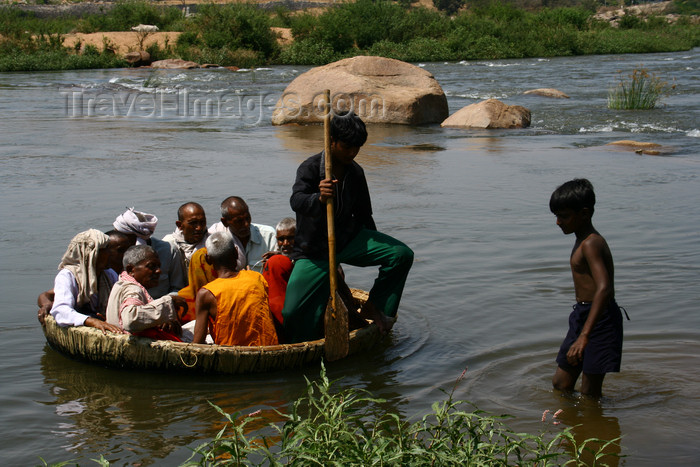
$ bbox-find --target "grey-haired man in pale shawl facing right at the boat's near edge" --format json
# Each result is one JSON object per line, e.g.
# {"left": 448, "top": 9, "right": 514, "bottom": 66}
{"left": 107, "top": 245, "right": 185, "bottom": 342}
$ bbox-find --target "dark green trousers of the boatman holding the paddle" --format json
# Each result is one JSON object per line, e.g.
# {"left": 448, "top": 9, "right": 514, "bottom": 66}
{"left": 282, "top": 229, "right": 413, "bottom": 343}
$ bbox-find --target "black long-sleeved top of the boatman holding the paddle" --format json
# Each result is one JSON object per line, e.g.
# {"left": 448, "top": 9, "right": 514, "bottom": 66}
{"left": 289, "top": 152, "right": 377, "bottom": 259}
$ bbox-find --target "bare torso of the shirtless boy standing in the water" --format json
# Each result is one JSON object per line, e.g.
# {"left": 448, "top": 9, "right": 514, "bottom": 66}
{"left": 571, "top": 230, "right": 615, "bottom": 302}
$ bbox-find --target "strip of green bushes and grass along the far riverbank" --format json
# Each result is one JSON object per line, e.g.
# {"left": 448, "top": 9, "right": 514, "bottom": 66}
{"left": 0, "top": 0, "right": 700, "bottom": 71}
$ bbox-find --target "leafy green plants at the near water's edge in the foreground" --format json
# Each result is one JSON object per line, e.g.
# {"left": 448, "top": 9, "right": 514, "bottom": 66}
{"left": 174, "top": 368, "right": 617, "bottom": 466}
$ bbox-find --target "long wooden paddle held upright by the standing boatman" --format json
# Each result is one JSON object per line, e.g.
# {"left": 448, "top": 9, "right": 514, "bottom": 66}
{"left": 323, "top": 89, "right": 349, "bottom": 361}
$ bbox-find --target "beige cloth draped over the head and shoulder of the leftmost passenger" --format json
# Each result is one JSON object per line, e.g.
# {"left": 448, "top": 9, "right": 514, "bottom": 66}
{"left": 58, "top": 229, "right": 109, "bottom": 306}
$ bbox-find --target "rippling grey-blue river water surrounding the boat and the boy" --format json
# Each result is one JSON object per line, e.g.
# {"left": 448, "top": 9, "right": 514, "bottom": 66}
{"left": 0, "top": 49, "right": 700, "bottom": 466}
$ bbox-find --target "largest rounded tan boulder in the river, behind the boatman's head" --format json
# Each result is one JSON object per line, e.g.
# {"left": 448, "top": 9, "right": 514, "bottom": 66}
{"left": 272, "top": 56, "right": 449, "bottom": 125}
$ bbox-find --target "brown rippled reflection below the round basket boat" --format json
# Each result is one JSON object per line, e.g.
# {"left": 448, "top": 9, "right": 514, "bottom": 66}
{"left": 41, "top": 346, "right": 296, "bottom": 465}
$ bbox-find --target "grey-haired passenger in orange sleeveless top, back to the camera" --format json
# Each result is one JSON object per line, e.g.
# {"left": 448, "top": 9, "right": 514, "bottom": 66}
{"left": 193, "top": 232, "right": 278, "bottom": 346}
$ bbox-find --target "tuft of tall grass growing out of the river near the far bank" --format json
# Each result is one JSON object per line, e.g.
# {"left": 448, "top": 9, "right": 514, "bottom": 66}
{"left": 608, "top": 68, "right": 669, "bottom": 110}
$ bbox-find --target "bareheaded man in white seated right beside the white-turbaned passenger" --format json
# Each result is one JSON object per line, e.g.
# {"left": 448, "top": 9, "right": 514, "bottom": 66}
{"left": 163, "top": 201, "right": 209, "bottom": 277}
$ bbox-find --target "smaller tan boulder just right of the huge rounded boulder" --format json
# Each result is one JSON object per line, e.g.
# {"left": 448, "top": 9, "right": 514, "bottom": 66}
{"left": 440, "top": 99, "right": 530, "bottom": 128}
